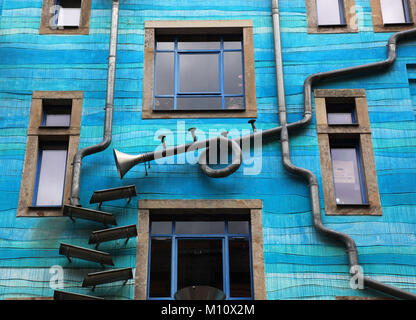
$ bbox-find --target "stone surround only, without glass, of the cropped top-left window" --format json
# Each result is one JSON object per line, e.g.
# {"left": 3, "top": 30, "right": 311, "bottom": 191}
{"left": 39, "top": 0, "right": 91, "bottom": 35}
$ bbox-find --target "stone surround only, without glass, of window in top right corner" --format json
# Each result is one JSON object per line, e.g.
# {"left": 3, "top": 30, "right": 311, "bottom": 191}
{"left": 370, "top": 0, "right": 416, "bottom": 32}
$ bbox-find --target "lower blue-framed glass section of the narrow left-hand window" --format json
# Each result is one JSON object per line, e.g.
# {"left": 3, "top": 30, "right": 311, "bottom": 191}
{"left": 32, "top": 142, "right": 68, "bottom": 207}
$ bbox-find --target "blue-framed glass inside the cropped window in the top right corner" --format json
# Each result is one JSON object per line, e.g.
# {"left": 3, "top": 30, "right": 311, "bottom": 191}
{"left": 380, "top": 0, "right": 413, "bottom": 25}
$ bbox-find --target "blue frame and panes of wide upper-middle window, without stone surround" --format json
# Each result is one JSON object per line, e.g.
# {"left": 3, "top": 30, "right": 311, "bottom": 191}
{"left": 153, "top": 34, "right": 245, "bottom": 111}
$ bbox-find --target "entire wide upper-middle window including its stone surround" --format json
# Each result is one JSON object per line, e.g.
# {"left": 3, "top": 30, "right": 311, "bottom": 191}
{"left": 142, "top": 20, "right": 257, "bottom": 119}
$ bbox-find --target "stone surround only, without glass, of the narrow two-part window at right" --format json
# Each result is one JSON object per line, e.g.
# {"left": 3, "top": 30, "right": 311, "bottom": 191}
{"left": 314, "top": 89, "right": 382, "bottom": 215}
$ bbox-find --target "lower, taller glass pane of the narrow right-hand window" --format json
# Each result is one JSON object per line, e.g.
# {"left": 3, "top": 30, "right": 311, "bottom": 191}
{"left": 331, "top": 148, "right": 363, "bottom": 204}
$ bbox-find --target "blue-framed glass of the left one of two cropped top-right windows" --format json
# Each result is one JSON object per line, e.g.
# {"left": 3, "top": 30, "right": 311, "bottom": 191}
{"left": 316, "top": 0, "right": 346, "bottom": 27}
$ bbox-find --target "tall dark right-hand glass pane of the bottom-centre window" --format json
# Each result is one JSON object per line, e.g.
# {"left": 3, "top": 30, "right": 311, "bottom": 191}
{"left": 228, "top": 239, "right": 251, "bottom": 298}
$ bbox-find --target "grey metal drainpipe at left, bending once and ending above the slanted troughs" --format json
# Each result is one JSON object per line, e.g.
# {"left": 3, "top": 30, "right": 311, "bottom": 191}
{"left": 70, "top": 0, "right": 120, "bottom": 206}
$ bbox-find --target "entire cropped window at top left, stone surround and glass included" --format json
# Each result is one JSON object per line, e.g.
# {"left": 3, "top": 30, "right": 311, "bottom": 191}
{"left": 39, "top": 0, "right": 91, "bottom": 35}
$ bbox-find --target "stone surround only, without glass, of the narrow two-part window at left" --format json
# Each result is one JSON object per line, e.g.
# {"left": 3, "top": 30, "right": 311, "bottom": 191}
{"left": 17, "top": 91, "right": 83, "bottom": 217}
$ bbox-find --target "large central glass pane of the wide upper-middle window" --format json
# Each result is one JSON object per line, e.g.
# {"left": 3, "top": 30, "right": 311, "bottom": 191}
{"left": 179, "top": 54, "right": 220, "bottom": 93}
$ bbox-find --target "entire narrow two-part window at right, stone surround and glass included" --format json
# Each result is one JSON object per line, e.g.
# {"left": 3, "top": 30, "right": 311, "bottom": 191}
{"left": 315, "top": 89, "right": 381, "bottom": 215}
